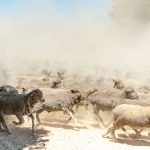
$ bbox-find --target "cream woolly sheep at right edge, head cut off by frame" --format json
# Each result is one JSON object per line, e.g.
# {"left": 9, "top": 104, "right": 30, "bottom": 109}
{"left": 103, "top": 104, "right": 150, "bottom": 141}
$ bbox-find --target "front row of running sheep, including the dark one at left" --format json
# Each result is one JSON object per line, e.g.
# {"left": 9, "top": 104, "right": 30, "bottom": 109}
{"left": 0, "top": 75, "right": 150, "bottom": 141}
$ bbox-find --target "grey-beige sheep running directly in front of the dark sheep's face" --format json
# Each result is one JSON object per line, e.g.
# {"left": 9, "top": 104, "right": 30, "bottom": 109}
{"left": 36, "top": 89, "right": 95, "bottom": 126}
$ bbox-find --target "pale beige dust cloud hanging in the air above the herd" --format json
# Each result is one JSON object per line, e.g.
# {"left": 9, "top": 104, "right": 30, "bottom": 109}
{"left": 0, "top": 0, "right": 150, "bottom": 84}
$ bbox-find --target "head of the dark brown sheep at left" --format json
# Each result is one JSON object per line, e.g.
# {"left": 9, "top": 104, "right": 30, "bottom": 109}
{"left": 26, "top": 89, "right": 45, "bottom": 107}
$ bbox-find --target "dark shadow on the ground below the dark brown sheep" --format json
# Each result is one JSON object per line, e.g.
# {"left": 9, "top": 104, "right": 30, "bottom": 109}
{"left": 0, "top": 125, "right": 49, "bottom": 150}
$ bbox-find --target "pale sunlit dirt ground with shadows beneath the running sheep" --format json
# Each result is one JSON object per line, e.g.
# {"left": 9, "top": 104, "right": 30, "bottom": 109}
{"left": 0, "top": 108, "right": 150, "bottom": 150}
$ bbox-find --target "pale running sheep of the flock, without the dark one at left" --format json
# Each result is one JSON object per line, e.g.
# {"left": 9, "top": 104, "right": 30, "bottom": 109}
{"left": 1, "top": 69, "right": 150, "bottom": 141}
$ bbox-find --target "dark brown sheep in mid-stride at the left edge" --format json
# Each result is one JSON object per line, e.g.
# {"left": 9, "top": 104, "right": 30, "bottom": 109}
{"left": 0, "top": 89, "right": 44, "bottom": 133}
